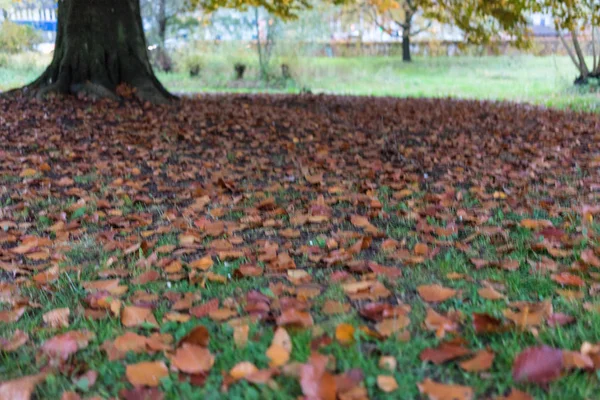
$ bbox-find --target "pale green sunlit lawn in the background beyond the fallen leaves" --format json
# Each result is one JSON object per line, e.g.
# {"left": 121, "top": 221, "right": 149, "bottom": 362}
{"left": 0, "top": 52, "right": 600, "bottom": 112}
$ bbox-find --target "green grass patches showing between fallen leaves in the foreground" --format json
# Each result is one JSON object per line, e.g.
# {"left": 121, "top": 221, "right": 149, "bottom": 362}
{"left": 0, "top": 193, "right": 600, "bottom": 399}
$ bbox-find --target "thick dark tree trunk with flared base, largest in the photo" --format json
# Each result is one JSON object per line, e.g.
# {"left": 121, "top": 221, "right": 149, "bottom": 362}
{"left": 24, "top": 0, "right": 174, "bottom": 103}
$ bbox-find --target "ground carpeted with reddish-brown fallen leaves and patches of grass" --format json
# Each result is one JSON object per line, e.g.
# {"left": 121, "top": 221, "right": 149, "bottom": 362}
{"left": 0, "top": 95, "right": 600, "bottom": 400}
